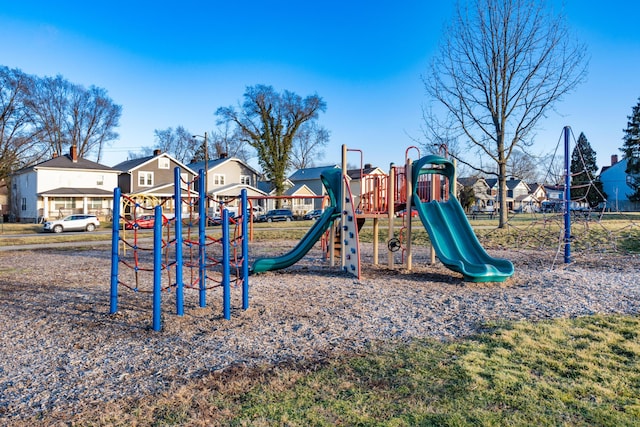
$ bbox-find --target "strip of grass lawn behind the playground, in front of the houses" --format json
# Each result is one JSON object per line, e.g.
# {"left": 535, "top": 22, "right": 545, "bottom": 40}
{"left": 5, "top": 213, "right": 640, "bottom": 253}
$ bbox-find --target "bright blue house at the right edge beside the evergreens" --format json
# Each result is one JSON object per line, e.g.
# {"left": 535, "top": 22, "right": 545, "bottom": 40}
{"left": 600, "top": 154, "right": 640, "bottom": 211}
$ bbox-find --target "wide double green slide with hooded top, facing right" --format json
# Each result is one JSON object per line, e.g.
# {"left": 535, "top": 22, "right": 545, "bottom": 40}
{"left": 412, "top": 156, "right": 513, "bottom": 282}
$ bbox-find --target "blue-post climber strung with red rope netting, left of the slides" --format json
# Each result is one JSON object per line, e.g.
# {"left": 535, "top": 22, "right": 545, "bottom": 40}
{"left": 111, "top": 169, "right": 248, "bottom": 329}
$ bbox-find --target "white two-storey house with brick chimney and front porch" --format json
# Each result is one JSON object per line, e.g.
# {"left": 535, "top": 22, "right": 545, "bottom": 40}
{"left": 10, "top": 145, "right": 118, "bottom": 222}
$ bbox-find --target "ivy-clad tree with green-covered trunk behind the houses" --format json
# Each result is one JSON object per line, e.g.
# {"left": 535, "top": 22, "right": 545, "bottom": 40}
{"left": 216, "top": 85, "right": 326, "bottom": 195}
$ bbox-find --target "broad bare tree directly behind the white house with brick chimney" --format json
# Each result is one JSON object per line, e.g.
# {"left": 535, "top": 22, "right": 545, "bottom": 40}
{"left": 27, "top": 75, "right": 122, "bottom": 161}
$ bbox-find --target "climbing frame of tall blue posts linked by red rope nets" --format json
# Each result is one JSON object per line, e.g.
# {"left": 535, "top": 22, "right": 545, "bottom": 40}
{"left": 110, "top": 168, "right": 250, "bottom": 330}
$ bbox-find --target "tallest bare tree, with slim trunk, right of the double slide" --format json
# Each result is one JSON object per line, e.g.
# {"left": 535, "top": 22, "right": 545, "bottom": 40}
{"left": 423, "top": 0, "right": 587, "bottom": 227}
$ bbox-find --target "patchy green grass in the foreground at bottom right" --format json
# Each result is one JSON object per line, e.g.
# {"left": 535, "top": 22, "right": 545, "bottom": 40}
{"left": 66, "top": 316, "right": 640, "bottom": 426}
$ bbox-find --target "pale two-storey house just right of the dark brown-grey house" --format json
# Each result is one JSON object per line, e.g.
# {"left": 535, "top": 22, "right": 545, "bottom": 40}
{"left": 189, "top": 155, "right": 267, "bottom": 212}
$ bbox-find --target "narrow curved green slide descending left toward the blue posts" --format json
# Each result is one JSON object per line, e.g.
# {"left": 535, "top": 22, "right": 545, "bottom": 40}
{"left": 251, "top": 169, "right": 342, "bottom": 273}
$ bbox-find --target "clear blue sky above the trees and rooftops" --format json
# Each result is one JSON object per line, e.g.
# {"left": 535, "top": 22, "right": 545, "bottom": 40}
{"left": 0, "top": 0, "right": 640, "bottom": 176}
